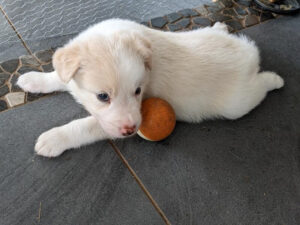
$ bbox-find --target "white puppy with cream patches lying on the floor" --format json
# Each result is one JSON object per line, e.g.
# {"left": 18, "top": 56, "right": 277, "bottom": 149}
{"left": 18, "top": 19, "right": 284, "bottom": 157}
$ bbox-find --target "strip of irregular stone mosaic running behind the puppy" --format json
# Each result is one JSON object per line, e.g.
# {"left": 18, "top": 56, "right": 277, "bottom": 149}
{"left": 0, "top": 0, "right": 282, "bottom": 111}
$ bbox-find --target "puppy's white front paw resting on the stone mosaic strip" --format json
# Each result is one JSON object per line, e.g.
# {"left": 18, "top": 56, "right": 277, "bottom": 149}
{"left": 17, "top": 72, "right": 45, "bottom": 93}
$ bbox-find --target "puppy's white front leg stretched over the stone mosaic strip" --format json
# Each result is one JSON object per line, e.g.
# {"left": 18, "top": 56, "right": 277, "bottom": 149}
{"left": 17, "top": 71, "right": 67, "bottom": 93}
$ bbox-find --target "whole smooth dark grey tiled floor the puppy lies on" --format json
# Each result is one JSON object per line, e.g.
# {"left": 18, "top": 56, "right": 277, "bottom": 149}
{"left": 0, "top": 0, "right": 300, "bottom": 225}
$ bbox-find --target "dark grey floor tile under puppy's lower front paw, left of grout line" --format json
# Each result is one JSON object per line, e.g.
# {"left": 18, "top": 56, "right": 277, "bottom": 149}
{"left": 0, "top": 95, "right": 163, "bottom": 225}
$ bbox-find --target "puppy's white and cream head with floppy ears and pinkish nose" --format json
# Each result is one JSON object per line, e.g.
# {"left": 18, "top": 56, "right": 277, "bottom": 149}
{"left": 53, "top": 32, "right": 151, "bottom": 138}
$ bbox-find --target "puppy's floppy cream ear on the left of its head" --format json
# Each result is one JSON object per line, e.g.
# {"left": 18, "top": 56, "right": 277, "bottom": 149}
{"left": 53, "top": 45, "right": 80, "bottom": 83}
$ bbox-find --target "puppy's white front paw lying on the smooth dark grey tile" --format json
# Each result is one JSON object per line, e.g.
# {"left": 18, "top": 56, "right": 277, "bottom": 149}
{"left": 34, "top": 128, "right": 69, "bottom": 157}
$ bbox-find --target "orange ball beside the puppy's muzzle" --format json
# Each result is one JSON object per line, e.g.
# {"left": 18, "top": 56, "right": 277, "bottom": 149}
{"left": 137, "top": 98, "right": 176, "bottom": 141}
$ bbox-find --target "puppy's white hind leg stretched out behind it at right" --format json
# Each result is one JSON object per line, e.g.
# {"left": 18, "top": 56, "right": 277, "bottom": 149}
{"left": 223, "top": 72, "right": 284, "bottom": 119}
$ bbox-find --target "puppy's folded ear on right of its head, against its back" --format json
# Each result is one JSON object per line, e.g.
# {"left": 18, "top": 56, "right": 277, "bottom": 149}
{"left": 134, "top": 34, "right": 152, "bottom": 71}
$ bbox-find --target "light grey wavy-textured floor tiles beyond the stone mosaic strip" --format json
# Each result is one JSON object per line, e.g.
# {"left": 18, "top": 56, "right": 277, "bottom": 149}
{"left": 0, "top": 0, "right": 210, "bottom": 62}
